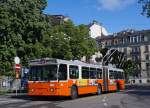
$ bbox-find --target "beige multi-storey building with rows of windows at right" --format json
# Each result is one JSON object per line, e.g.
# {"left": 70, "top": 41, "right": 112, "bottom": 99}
{"left": 99, "top": 30, "right": 150, "bottom": 81}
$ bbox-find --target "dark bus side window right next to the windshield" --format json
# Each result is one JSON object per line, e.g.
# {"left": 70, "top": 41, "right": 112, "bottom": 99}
{"left": 58, "top": 64, "right": 67, "bottom": 80}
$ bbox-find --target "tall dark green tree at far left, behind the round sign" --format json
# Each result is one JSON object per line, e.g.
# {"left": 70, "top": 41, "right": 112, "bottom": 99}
{"left": 0, "top": 0, "right": 50, "bottom": 76}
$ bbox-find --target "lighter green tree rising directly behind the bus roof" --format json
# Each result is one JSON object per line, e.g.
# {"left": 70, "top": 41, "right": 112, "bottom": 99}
{"left": 51, "top": 20, "right": 96, "bottom": 60}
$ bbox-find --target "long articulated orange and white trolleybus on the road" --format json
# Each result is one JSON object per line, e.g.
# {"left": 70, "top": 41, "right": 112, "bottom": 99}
{"left": 28, "top": 58, "right": 125, "bottom": 99}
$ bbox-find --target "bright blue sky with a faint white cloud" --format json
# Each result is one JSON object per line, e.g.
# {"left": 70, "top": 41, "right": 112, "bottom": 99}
{"left": 44, "top": 0, "right": 150, "bottom": 33}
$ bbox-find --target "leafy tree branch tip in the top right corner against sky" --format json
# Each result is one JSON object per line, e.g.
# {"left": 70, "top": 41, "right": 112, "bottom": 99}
{"left": 139, "top": 0, "right": 150, "bottom": 17}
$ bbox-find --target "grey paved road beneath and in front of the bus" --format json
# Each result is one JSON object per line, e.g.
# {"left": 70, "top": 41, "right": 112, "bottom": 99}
{"left": 0, "top": 85, "right": 150, "bottom": 108}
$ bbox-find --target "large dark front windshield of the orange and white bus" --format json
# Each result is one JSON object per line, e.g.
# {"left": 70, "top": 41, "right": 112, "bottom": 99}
{"left": 29, "top": 65, "right": 57, "bottom": 81}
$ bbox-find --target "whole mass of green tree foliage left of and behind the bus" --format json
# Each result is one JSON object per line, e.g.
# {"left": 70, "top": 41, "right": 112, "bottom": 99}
{"left": 0, "top": 0, "right": 96, "bottom": 76}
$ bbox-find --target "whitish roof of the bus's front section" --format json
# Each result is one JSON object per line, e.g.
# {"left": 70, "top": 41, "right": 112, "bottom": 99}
{"left": 29, "top": 58, "right": 102, "bottom": 68}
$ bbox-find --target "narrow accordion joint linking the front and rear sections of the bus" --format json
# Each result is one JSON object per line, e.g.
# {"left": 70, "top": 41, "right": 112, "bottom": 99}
{"left": 103, "top": 67, "right": 108, "bottom": 91}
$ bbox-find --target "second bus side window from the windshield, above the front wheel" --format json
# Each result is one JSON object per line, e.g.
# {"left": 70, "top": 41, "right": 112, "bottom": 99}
{"left": 69, "top": 65, "right": 79, "bottom": 79}
